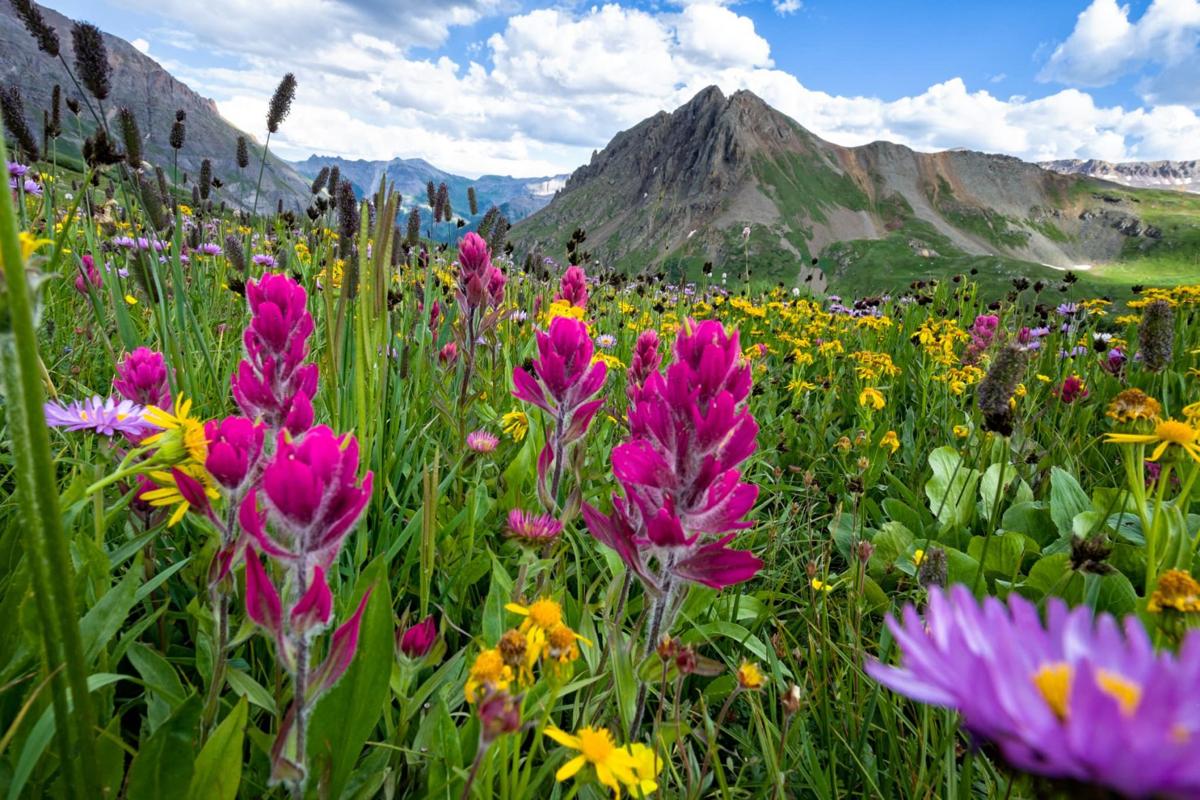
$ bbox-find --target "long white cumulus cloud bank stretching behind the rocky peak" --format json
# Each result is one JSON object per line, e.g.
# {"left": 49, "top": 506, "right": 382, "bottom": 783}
{"left": 131, "top": 0, "right": 1200, "bottom": 176}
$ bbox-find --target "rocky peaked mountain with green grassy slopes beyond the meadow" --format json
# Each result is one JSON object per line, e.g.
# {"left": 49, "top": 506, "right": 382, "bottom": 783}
{"left": 509, "top": 86, "right": 1200, "bottom": 290}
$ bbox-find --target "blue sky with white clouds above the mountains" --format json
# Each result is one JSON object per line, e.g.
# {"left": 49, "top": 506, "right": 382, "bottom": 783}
{"left": 42, "top": 0, "right": 1200, "bottom": 178}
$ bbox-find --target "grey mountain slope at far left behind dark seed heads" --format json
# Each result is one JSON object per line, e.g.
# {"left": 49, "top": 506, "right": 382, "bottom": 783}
{"left": 0, "top": 0, "right": 308, "bottom": 209}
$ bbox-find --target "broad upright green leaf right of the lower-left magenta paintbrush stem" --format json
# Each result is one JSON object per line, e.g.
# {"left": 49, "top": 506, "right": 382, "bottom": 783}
{"left": 308, "top": 557, "right": 396, "bottom": 798}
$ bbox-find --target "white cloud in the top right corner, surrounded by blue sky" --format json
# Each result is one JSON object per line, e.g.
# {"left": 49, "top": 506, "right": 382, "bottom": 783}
{"left": 1039, "top": 0, "right": 1200, "bottom": 106}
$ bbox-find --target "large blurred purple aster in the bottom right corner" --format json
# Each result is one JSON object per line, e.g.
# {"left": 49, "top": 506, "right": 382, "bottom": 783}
{"left": 866, "top": 585, "right": 1200, "bottom": 798}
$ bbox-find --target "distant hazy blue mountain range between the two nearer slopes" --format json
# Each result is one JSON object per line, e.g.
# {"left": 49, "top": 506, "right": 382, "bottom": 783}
{"left": 293, "top": 155, "right": 566, "bottom": 235}
